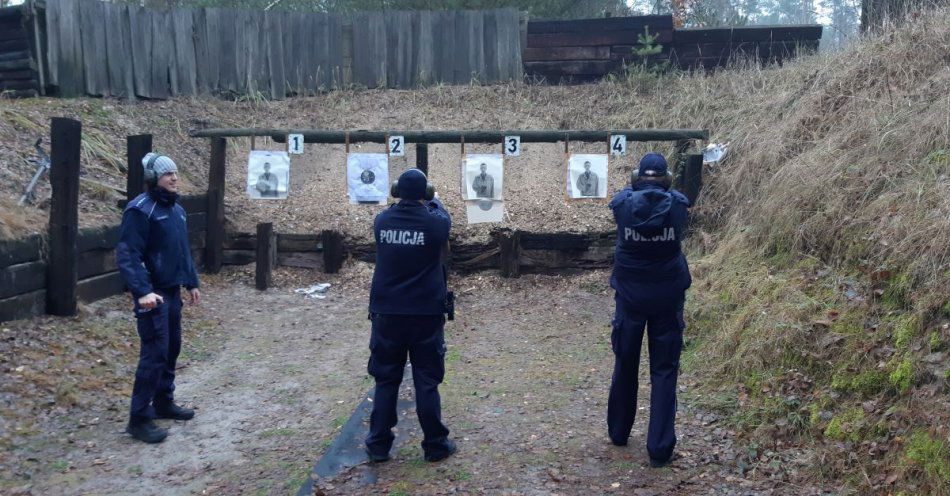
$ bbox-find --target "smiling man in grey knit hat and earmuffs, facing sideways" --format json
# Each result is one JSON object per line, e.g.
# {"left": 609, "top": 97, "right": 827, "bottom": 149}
{"left": 116, "top": 153, "right": 201, "bottom": 443}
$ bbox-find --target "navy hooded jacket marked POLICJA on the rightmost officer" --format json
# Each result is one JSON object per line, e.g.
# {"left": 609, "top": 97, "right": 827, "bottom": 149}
{"left": 610, "top": 182, "right": 692, "bottom": 313}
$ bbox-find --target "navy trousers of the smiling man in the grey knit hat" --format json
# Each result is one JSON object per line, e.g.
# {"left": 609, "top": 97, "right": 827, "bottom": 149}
{"left": 130, "top": 288, "right": 181, "bottom": 423}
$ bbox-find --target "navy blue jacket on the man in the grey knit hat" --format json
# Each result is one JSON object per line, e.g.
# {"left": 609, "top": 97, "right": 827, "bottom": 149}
{"left": 115, "top": 193, "right": 198, "bottom": 298}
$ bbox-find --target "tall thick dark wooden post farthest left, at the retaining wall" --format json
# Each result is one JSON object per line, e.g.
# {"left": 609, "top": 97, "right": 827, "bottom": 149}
{"left": 46, "top": 117, "right": 82, "bottom": 316}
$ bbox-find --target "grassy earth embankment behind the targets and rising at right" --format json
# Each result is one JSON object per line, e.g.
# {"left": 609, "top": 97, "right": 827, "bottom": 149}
{"left": 0, "top": 9, "right": 950, "bottom": 494}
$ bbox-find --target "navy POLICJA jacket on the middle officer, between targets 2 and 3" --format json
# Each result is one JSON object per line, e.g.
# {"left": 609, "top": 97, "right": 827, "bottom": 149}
{"left": 369, "top": 199, "right": 452, "bottom": 315}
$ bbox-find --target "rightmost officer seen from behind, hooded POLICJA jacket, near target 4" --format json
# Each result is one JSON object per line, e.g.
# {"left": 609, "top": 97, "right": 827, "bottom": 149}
{"left": 607, "top": 153, "right": 692, "bottom": 467}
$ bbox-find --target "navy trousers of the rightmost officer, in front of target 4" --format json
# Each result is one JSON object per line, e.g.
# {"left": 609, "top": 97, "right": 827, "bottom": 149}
{"left": 607, "top": 294, "right": 685, "bottom": 461}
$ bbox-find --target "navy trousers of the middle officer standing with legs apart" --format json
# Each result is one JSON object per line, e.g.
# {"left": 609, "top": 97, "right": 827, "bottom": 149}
{"left": 366, "top": 314, "right": 449, "bottom": 456}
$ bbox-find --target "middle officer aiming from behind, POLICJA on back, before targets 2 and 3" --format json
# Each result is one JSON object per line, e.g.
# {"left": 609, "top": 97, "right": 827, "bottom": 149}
{"left": 366, "top": 169, "right": 456, "bottom": 462}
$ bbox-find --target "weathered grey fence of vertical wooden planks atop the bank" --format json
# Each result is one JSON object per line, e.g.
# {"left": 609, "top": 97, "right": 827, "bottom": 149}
{"left": 39, "top": 0, "right": 521, "bottom": 99}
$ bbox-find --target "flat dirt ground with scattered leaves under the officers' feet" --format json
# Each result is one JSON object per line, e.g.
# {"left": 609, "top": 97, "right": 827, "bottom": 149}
{"left": 0, "top": 264, "right": 822, "bottom": 495}
